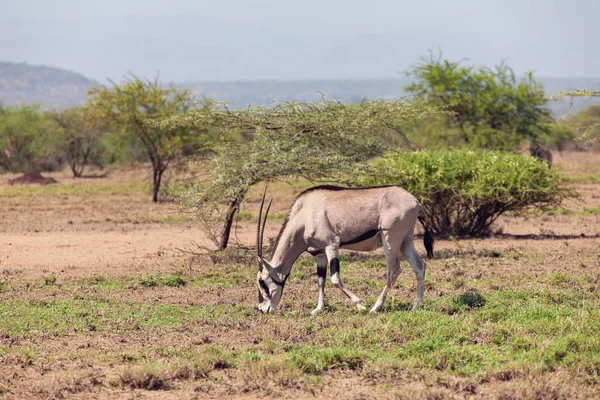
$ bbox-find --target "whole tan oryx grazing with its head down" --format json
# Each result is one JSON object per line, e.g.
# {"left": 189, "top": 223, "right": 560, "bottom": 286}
{"left": 256, "top": 186, "right": 425, "bottom": 314}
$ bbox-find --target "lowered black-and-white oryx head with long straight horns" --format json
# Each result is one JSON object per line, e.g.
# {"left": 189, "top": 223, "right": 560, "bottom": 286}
{"left": 256, "top": 188, "right": 284, "bottom": 313}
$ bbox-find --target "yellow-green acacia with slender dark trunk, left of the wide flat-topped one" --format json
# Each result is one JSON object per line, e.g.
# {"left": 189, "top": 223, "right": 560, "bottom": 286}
{"left": 87, "top": 76, "right": 198, "bottom": 203}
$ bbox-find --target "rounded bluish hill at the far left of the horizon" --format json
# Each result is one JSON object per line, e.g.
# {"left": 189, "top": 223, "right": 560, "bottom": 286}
{"left": 0, "top": 61, "right": 95, "bottom": 108}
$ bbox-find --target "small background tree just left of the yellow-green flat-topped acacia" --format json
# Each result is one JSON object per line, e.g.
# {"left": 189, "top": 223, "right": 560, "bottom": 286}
{"left": 48, "top": 107, "right": 109, "bottom": 178}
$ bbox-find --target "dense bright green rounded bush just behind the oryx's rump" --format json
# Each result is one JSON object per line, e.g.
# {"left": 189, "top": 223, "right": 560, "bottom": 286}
{"left": 360, "top": 150, "right": 576, "bottom": 237}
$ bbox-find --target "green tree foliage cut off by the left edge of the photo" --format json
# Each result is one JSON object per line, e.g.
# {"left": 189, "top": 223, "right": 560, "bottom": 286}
{"left": 0, "top": 105, "right": 50, "bottom": 171}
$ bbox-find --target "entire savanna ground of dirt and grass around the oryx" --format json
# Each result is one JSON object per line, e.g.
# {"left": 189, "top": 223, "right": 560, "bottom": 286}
{"left": 0, "top": 153, "right": 600, "bottom": 399}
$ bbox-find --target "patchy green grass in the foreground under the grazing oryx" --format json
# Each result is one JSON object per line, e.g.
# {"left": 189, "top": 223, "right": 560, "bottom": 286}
{"left": 0, "top": 255, "right": 600, "bottom": 396}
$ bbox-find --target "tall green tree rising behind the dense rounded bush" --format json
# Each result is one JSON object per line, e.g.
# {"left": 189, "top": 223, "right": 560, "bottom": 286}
{"left": 405, "top": 55, "right": 551, "bottom": 150}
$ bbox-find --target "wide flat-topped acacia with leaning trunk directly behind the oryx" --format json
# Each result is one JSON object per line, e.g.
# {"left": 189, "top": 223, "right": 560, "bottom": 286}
{"left": 157, "top": 99, "right": 434, "bottom": 250}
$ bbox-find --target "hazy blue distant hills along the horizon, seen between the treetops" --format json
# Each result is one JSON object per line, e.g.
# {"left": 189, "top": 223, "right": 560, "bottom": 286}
{"left": 0, "top": 62, "right": 600, "bottom": 116}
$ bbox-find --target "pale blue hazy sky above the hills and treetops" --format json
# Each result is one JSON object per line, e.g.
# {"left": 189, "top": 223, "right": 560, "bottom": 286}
{"left": 0, "top": 0, "right": 600, "bottom": 80}
